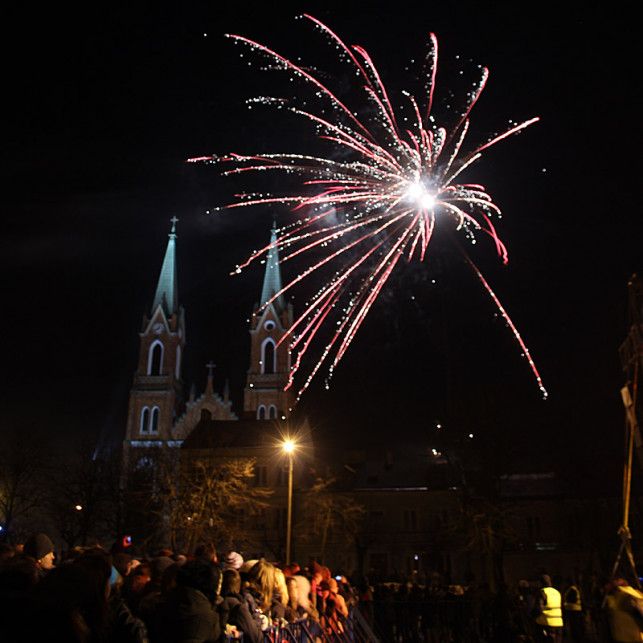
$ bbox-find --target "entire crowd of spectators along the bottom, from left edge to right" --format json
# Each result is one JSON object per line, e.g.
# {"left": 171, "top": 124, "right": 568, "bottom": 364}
{"left": 0, "top": 533, "right": 643, "bottom": 643}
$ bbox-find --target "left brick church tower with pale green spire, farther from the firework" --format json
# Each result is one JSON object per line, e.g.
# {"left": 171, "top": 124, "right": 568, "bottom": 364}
{"left": 124, "top": 217, "right": 185, "bottom": 454}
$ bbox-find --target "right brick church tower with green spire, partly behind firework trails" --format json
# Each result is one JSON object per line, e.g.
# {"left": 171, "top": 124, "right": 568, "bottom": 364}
{"left": 243, "top": 225, "right": 294, "bottom": 420}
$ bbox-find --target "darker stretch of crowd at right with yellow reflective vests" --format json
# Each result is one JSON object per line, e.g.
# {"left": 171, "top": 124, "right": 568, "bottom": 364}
{"left": 358, "top": 574, "right": 643, "bottom": 643}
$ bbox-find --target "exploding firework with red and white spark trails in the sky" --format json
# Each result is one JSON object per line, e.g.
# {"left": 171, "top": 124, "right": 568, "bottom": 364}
{"left": 189, "top": 15, "right": 547, "bottom": 398}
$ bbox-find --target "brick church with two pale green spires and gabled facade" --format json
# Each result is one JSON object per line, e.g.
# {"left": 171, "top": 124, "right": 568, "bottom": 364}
{"left": 124, "top": 218, "right": 293, "bottom": 460}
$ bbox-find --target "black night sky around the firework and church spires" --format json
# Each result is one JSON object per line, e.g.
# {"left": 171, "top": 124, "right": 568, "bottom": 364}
{"left": 0, "top": 2, "right": 643, "bottom": 478}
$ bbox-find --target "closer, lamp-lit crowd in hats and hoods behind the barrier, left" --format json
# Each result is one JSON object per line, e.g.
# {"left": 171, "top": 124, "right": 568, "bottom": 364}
{"left": 0, "top": 533, "right": 354, "bottom": 643}
